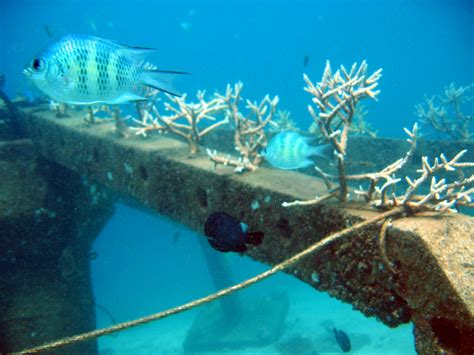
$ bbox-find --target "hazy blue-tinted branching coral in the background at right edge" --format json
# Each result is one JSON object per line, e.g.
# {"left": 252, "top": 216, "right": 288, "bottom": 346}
{"left": 415, "top": 83, "right": 474, "bottom": 141}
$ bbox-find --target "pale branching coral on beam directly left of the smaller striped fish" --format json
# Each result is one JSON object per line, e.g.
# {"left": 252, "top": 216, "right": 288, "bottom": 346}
{"left": 208, "top": 82, "right": 279, "bottom": 172}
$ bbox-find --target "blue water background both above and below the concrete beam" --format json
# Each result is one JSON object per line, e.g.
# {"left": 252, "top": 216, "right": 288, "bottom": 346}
{"left": 0, "top": 0, "right": 474, "bottom": 354}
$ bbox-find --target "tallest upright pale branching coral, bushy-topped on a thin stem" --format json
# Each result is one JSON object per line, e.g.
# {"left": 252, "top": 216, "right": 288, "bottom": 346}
{"left": 304, "top": 61, "right": 382, "bottom": 201}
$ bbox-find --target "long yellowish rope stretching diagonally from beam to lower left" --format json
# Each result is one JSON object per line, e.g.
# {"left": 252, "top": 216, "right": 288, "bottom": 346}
{"left": 17, "top": 207, "right": 403, "bottom": 354}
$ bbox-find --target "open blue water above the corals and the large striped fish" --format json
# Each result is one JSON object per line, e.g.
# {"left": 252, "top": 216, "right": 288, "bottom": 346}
{"left": 0, "top": 0, "right": 474, "bottom": 136}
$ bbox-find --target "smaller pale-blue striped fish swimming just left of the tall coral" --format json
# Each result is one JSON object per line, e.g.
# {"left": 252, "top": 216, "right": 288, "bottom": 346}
{"left": 262, "top": 132, "right": 329, "bottom": 170}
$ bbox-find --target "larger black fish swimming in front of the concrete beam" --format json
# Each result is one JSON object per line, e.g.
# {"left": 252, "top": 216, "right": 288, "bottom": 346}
{"left": 204, "top": 212, "right": 264, "bottom": 253}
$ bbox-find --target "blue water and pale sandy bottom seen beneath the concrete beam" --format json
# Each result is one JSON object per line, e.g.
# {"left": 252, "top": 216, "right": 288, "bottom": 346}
{"left": 92, "top": 204, "right": 416, "bottom": 355}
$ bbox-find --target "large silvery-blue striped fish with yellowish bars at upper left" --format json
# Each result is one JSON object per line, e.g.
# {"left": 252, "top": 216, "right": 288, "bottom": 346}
{"left": 24, "top": 35, "right": 187, "bottom": 105}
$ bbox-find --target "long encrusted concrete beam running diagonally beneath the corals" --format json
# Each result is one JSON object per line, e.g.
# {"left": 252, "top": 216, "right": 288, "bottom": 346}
{"left": 23, "top": 110, "right": 474, "bottom": 353}
